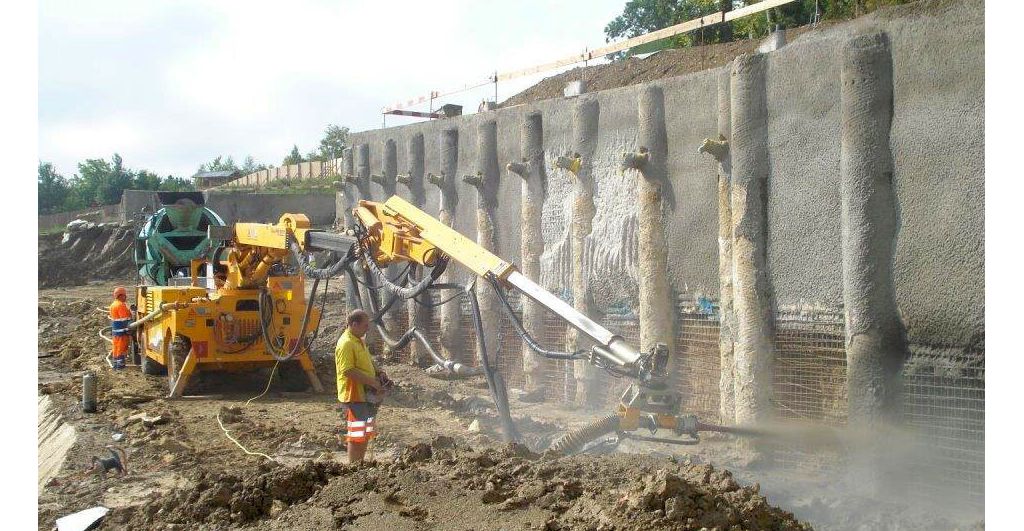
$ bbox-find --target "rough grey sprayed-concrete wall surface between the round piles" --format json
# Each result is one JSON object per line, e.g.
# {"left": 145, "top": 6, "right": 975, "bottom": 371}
{"left": 351, "top": 0, "right": 984, "bottom": 360}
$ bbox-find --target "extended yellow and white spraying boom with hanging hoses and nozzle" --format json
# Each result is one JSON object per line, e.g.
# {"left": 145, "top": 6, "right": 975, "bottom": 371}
{"left": 353, "top": 195, "right": 750, "bottom": 452}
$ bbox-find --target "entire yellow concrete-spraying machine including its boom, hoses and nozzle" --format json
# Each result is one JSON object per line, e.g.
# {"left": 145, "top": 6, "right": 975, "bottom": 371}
{"left": 131, "top": 195, "right": 738, "bottom": 452}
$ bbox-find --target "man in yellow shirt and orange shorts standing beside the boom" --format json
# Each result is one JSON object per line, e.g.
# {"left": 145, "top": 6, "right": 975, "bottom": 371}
{"left": 334, "top": 310, "right": 391, "bottom": 462}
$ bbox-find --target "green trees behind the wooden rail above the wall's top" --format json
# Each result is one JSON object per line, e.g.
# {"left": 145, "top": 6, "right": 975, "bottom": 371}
{"left": 604, "top": 0, "right": 914, "bottom": 59}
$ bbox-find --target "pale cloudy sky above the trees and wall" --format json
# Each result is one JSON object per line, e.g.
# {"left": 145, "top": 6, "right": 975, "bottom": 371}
{"left": 38, "top": 0, "right": 626, "bottom": 176}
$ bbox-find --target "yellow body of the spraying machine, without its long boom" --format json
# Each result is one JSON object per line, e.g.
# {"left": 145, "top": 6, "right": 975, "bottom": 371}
{"left": 130, "top": 214, "right": 354, "bottom": 397}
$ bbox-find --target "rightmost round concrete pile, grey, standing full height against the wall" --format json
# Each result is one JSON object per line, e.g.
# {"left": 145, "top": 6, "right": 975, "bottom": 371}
{"left": 840, "top": 33, "right": 907, "bottom": 425}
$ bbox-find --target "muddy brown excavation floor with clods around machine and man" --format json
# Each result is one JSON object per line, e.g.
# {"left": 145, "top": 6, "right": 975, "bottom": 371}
{"left": 38, "top": 281, "right": 983, "bottom": 529}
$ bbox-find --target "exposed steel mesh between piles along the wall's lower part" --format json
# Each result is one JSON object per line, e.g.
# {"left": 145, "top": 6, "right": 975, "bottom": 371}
{"left": 346, "top": 286, "right": 985, "bottom": 507}
